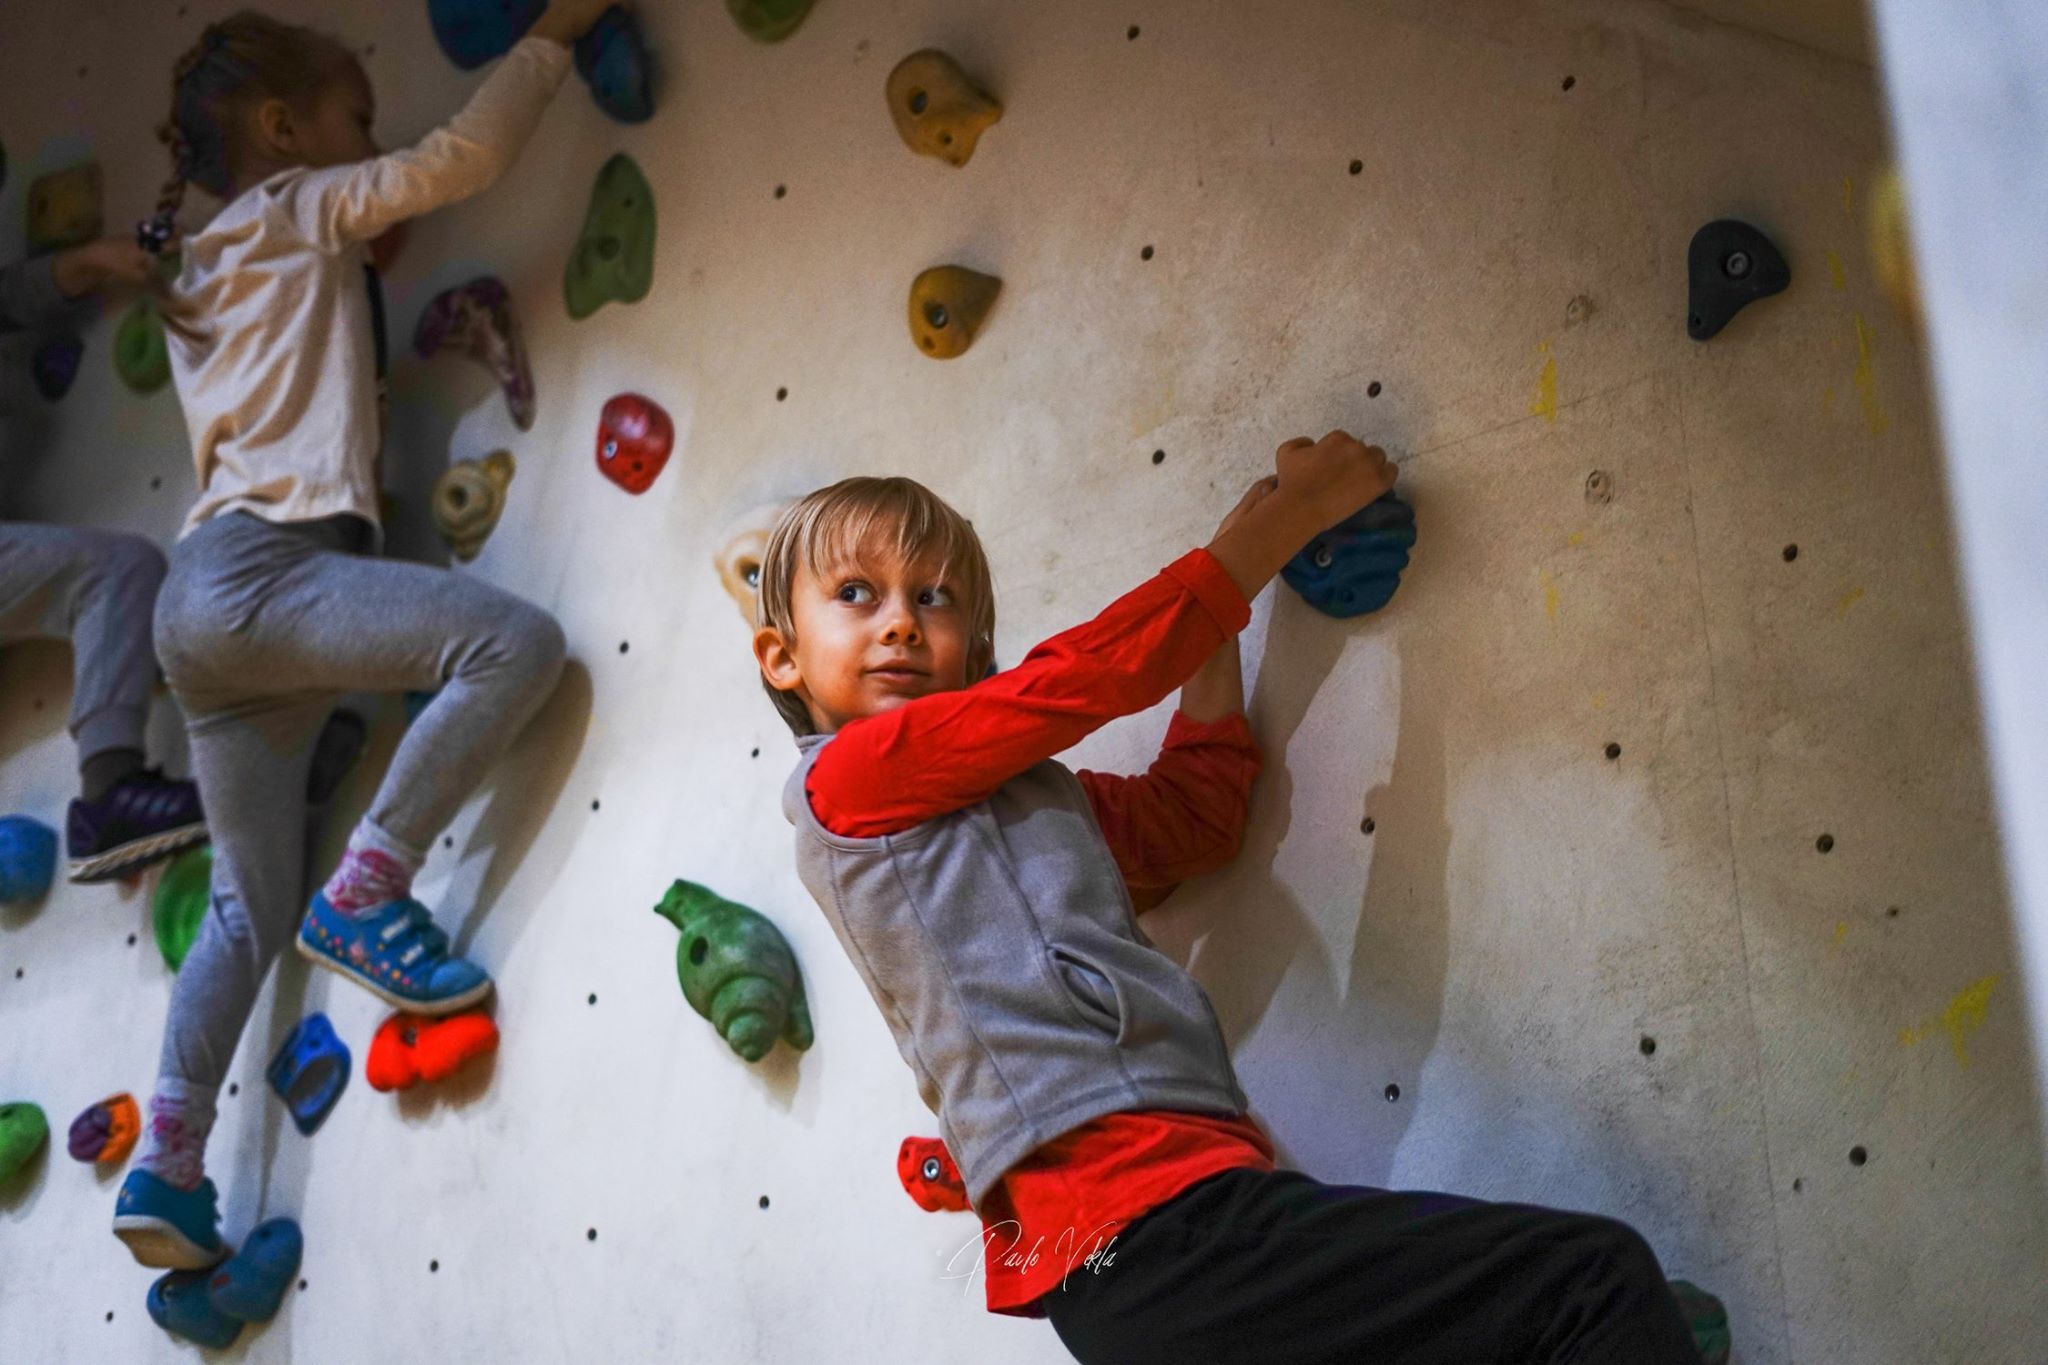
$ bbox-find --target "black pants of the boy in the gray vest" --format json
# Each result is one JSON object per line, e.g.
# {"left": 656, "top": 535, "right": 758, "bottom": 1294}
{"left": 1042, "top": 1169, "right": 1700, "bottom": 1365}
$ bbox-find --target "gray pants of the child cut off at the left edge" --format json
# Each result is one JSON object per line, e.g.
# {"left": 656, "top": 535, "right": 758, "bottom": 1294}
{"left": 0, "top": 522, "right": 164, "bottom": 763}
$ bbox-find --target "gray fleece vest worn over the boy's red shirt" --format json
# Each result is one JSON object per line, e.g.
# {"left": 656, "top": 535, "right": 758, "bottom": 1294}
{"left": 782, "top": 735, "right": 1245, "bottom": 1207}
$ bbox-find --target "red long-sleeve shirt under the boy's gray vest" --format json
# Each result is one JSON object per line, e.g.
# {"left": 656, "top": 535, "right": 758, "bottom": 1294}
{"left": 805, "top": 551, "right": 1274, "bottom": 1318}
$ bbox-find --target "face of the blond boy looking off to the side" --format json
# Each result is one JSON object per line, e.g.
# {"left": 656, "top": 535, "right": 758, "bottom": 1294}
{"left": 754, "top": 548, "right": 969, "bottom": 735}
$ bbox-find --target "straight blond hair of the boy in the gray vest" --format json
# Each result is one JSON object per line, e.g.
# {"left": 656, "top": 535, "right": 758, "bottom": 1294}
{"left": 754, "top": 477, "right": 995, "bottom": 735}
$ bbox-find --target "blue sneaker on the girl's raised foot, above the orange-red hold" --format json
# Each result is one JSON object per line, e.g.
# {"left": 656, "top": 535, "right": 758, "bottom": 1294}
{"left": 299, "top": 890, "right": 492, "bottom": 1015}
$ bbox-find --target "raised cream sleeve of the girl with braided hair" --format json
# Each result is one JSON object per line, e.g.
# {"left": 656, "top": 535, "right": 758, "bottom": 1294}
{"left": 283, "top": 33, "right": 569, "bottom": 252}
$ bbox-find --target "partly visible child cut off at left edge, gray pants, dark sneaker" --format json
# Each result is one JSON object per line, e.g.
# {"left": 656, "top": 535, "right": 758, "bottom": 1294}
{"left": 0, "top": 237, "right": 207, "bottom": 882}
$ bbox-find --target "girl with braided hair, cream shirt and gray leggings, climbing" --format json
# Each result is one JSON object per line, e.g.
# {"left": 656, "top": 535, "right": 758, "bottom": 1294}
{"left": 115, "top": 0, "right": 604, "bottom": 1340}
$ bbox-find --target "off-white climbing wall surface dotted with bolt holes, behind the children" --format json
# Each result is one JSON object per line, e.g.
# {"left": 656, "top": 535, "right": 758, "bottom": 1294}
{"left": 0, "top": 0, "right": 2048, "bottom": 1365}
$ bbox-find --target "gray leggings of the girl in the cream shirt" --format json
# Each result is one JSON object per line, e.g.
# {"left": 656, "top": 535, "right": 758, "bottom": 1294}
{"left": 156, "top": 512, "right": 563, "bottom": 1089}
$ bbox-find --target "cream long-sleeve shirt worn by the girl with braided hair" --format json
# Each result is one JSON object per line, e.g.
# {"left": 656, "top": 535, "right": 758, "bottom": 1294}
{"left": 164, "top": 39, "right": 569, "bottom": 538}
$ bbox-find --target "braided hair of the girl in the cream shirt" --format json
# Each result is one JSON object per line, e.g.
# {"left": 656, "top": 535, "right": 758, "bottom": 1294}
{"left": 141, "top": 10, "right": 350, "bottom": 250}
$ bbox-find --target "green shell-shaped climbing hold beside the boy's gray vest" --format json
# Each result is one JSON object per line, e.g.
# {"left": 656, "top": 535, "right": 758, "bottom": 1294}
{"left": 653, "top": 880, "right": 813, "bottom": 1062}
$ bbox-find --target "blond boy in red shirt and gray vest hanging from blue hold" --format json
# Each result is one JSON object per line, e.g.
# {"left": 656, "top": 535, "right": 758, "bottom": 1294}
{"left": 754, "top": 432, "right": 1700, "bottom": 1365}
